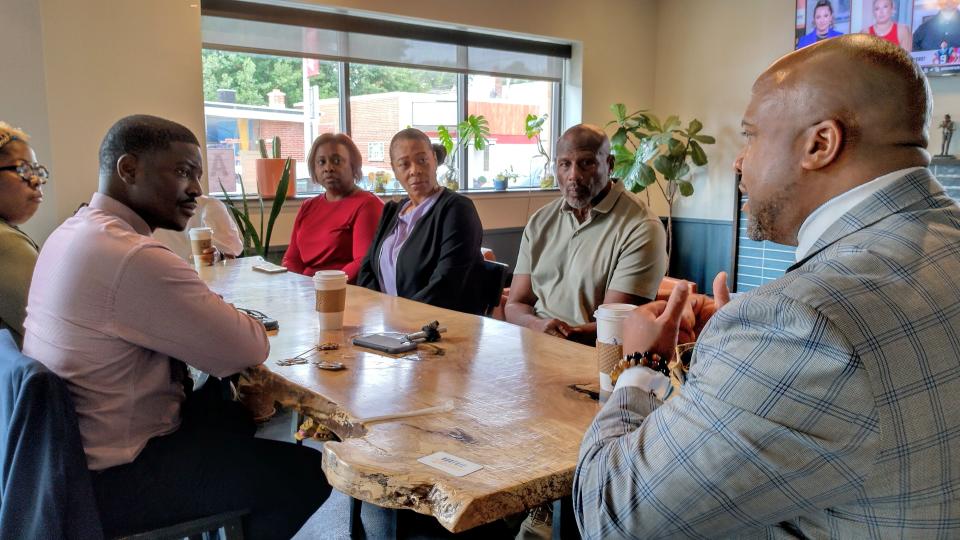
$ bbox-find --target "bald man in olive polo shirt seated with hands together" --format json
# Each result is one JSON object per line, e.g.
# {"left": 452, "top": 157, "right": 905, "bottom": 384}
{"left": 505, "top": 124, "right": 667, "bottom": 344}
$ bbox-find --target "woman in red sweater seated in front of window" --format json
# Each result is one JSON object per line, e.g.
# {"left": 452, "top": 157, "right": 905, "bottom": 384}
{"left": 283, "top": 133, "right": 383, "bottom": 283}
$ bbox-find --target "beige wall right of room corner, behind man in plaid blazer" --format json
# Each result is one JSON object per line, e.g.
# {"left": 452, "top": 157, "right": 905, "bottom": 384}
{"left": 653, "top": 0, "right": 960, "bottom": 220}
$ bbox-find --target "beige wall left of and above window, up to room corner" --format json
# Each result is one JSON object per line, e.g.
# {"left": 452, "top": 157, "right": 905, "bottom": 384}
{"left": 0, "top": 0, "right": 657, "bottom": 241}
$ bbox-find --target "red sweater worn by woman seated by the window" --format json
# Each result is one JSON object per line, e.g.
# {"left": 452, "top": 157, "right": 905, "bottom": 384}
{"left": 283, "top": 189, "right": 383, "bottom": 283}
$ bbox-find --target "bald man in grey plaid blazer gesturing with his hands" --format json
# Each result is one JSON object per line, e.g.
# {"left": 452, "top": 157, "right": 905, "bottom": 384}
{"left": 573, "top": 35, "right": 960, "bottom": 538}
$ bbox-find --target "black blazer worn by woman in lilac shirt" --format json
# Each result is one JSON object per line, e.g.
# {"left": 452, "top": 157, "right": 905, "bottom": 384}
{"left": 357, "top": 189, "right": 483, "bottom": 314}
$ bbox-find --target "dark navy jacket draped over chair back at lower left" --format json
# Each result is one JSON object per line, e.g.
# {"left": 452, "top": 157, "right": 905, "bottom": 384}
{"left": 0, "top": 330, "right": 103, "bottom": 540}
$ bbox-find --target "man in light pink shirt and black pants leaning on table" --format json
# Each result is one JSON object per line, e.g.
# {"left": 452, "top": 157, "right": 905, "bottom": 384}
{"left": 24, "top": 115, "right": 330, "bottom": 538}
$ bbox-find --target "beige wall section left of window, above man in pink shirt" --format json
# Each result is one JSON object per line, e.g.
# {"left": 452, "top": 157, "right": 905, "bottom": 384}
{"left": 40, "top": 0, "right": 204, "bottom": 230}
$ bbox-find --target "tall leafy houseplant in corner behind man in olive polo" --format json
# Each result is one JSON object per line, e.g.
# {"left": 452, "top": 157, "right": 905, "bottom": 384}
{"left": 607, "top": 103, "right": 716, "bottom": 262}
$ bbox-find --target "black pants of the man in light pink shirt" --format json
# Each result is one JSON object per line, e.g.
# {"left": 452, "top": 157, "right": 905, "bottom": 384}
{"left": 92, "top": 381, "right": 330, "bottom": 539}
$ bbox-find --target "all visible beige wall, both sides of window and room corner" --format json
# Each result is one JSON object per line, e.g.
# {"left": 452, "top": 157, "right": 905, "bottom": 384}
{"left": 9, "top": 0, "right": 960, "bottom": 240}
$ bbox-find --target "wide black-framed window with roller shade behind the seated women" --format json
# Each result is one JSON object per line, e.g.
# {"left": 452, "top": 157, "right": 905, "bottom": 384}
{"left": 201, "top": 0, "right": 571, "bottom": 194}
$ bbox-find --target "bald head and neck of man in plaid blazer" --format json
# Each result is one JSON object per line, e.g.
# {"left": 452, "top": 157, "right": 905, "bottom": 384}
{"left": 734, "top": 34, "right": 932, "bottom": 245}
